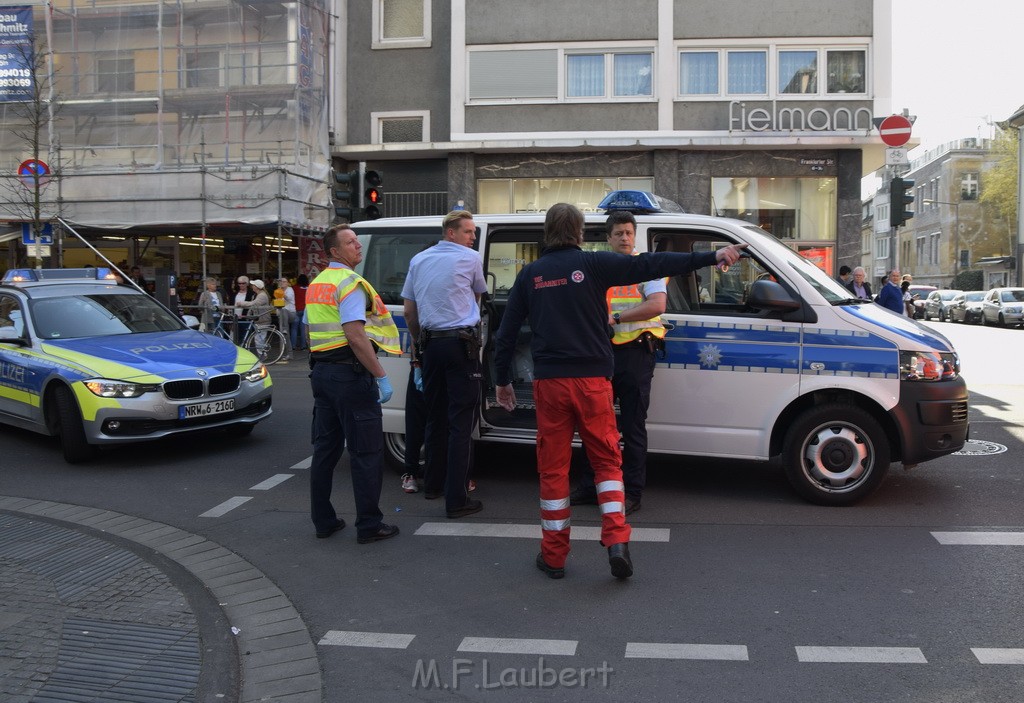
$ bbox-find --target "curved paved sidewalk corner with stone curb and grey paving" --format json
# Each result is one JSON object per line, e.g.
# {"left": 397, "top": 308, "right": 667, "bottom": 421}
{"left": 0, "top": 496, "right": 322, "bottom": 703}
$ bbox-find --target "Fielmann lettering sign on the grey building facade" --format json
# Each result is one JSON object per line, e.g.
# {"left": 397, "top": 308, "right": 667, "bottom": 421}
{"left": 729, "top": 100, "right": 873, "bottom": 133}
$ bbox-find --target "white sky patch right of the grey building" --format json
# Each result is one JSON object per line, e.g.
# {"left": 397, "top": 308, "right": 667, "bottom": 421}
{"left": 892, "top": 0, "right": 1024, "bottom": 154}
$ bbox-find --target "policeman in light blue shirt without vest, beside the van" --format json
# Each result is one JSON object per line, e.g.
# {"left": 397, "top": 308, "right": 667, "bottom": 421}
{"left": 401, "top": 210, "right": 487, "bottom": 518}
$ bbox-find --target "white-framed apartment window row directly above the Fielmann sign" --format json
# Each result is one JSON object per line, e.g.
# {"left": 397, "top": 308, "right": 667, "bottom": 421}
{"left": 678, "top": 41, "right": 867, "bottom": 98}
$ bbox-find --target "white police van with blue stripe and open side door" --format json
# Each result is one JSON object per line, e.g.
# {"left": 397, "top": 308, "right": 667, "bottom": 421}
{"left": 352, "top": 191, "right": 969, "bottom": 506}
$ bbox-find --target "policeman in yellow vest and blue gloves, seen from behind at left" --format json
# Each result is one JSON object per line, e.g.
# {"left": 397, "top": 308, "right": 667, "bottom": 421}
{"left": 306, "top": 224, "right": 401, "bottom": 544}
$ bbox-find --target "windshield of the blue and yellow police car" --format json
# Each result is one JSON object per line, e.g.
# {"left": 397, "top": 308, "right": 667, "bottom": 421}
{"left": 31, "top": 294, "right": 184, "bottom": 340}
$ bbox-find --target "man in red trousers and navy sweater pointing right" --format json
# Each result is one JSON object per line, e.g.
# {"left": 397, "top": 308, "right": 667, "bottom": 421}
{"left": 495, "top": 203, "right": 745, "bottom": 578}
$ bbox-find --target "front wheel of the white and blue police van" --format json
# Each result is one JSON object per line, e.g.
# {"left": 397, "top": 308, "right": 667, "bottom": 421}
{"left": 782, "top": 403, "right": 890, "bottom": 506}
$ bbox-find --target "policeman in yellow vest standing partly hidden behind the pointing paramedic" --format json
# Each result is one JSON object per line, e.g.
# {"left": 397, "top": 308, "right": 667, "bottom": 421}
{"left": 569, "top": 211, "right": 668, "bottom": 515}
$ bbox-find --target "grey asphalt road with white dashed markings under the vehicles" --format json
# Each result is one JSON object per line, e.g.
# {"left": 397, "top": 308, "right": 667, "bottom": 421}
{"left": 0, "top": 322, "right": 1024, "bottom": 703}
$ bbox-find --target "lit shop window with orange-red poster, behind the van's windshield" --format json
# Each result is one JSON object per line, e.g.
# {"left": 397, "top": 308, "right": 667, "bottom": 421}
{"left": 712, "top": 177, "right": 837, "bottom": 240}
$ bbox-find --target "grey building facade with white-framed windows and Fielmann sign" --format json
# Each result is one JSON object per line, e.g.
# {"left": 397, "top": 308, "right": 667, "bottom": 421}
{"left": 333, "top": 0, "right": 891, "bottom": 273}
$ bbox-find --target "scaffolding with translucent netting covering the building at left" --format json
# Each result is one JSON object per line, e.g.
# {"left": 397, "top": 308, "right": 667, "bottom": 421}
{"left": 0, "top": 0, "right": 331, "bottom": 275}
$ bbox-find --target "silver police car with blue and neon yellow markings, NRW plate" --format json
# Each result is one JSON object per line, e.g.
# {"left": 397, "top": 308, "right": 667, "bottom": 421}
{"left": 0, "top": 268, "right": 272, "bottom": 464}
